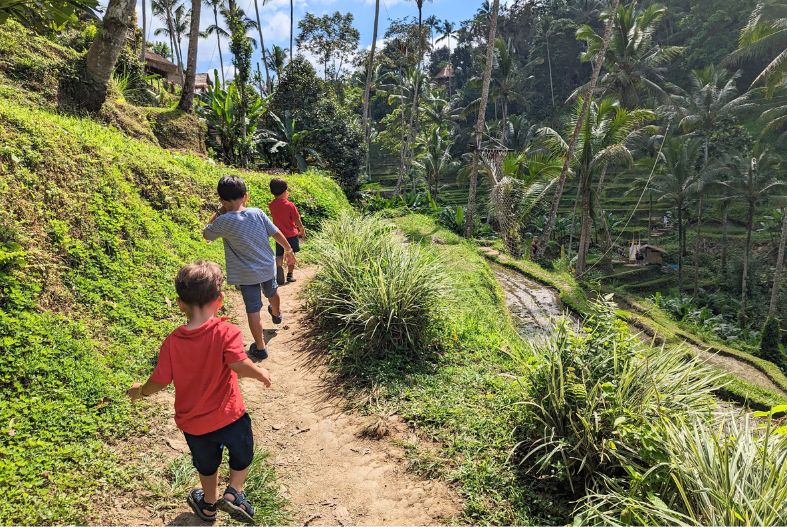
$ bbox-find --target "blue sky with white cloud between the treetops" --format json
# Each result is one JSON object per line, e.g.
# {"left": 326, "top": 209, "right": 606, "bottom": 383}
{"left": 137, "top": 0, "right": 490, "bottom": 76}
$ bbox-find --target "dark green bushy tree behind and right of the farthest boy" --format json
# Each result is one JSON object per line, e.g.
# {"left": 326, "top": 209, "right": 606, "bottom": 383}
{"left": 271, "top": 57, "right": 366, "bottom": 196}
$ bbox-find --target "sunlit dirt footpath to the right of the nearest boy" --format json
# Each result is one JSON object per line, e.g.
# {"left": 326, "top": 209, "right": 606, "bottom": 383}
{"left": 232, "top": 268, "right": 461, "bottom": 525}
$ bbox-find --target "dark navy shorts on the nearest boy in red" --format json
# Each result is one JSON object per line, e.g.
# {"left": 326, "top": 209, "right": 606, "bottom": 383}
{"left": 183, "top": 414, "right": 254, "bottom": 476}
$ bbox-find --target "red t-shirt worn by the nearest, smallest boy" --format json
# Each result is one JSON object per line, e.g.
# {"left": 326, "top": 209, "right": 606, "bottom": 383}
{"left": 150, "top": 317, "right": 246, "bottom": 435}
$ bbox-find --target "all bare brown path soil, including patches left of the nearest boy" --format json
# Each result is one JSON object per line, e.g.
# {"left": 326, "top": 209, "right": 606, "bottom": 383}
{"left": 96, "top": 268, "right": 461, "bottom": 525}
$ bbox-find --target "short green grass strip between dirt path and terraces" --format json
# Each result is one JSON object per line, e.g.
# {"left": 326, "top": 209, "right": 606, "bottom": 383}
{"left": 315, "top": 215, "right": 570, "bottom": 524}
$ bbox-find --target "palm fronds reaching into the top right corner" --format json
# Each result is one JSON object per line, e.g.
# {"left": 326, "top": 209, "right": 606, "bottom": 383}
{"left": 729, "top": 0, "right": 787, "bottom": 88}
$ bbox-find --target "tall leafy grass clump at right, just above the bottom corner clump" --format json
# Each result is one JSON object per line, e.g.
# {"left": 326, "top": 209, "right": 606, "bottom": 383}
{"left": 518, "top": 299, "right": 718, "bottom": 494}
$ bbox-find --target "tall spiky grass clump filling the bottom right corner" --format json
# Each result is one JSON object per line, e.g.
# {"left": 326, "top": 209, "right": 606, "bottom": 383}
{"left": 578, "top": 417, "right": 787, "bottom": 526}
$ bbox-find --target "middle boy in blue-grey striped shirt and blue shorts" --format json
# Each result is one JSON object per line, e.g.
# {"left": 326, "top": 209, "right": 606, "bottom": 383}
{"left": 202, "top": 176, "right": 296, "bottom": 359}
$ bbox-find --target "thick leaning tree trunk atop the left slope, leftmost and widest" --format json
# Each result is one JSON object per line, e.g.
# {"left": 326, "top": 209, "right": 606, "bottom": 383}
{"left": 77, "top": 0, "right": 136, "bottom": 112}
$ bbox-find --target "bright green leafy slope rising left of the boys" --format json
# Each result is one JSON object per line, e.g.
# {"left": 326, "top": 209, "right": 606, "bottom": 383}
{"left": 0, "top": 91, "right": 348, "bottom": 524}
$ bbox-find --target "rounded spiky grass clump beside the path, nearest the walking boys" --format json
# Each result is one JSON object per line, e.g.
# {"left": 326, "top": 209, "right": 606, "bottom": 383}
{"left": 307, "top": 213, "right": 448, "bottom": 361}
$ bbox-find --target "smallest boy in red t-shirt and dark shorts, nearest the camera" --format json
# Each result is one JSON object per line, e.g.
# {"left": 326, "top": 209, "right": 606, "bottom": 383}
{"left": 128, "top": 261, "right": 271, "bottom": 522}
